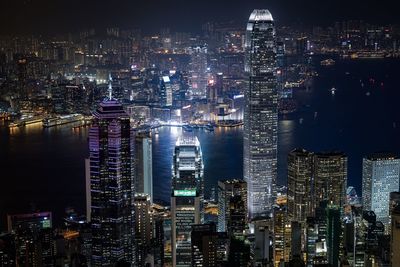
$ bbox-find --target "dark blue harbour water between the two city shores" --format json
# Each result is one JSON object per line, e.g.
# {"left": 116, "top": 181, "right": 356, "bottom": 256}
{"left": 0, "top": 60, "right": 400, "bottom": 229}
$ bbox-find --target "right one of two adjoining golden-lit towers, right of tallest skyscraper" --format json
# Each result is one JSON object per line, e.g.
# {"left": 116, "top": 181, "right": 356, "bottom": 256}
{"left": 314, "top": 152, "right": 347, "bottom": 207}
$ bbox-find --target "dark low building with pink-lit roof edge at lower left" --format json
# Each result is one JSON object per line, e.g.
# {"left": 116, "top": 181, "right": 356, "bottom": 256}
{"left": 7, "top": 212, "right": 54, "bottom": 266}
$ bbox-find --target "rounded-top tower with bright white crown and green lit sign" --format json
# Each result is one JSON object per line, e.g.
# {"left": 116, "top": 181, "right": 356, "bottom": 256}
{"left": 171, "top": 136, "right": 204, "bottom": 267}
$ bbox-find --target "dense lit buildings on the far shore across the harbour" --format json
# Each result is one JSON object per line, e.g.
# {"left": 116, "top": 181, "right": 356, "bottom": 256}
{"left": 0, "top": 7, "right": 400, "bottom": 125}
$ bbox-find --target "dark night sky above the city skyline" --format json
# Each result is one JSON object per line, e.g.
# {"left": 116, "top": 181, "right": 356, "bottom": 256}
{"left": 0, "top": 0, "right": 400, "bottom": 34}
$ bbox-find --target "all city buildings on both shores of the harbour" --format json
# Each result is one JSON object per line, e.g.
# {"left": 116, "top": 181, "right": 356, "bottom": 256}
{"left": 0, "top": 7, "right": 400, "bottom": 267}
